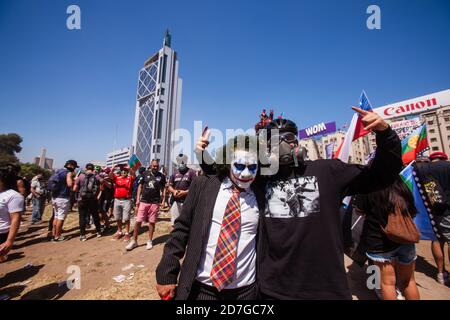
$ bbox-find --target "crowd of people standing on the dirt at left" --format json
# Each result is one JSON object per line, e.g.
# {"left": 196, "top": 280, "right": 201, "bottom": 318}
{"left": 0, "top": 155, "right": 197, "bottom": 256}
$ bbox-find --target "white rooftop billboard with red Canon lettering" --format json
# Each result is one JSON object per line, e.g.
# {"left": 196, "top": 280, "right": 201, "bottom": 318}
{"left": 374, "top": 89, "right": 450, "bottom": 119}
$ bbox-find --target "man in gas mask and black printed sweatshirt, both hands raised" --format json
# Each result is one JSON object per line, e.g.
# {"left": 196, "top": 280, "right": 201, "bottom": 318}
{"left": 196, "top": 108, "right": 402, "bottom": 299}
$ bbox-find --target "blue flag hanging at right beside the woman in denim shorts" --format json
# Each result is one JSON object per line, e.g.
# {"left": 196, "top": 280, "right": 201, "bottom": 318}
{"left": 400, "top": 161, "right": 436, "bottom": 240}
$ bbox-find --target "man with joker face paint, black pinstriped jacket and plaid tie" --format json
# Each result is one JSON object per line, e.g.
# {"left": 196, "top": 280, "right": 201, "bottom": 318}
{"left": 156, "top": 136, "right": 264, "bottom": 300}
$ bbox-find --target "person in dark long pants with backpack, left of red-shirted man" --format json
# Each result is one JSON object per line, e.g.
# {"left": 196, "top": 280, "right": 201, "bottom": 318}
{"left": 73, "top": 163, "right": 102, "bottom": 241}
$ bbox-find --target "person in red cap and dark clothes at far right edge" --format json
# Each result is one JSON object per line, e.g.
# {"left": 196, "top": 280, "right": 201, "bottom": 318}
{"left": 417, "top": 151, "right": 450, "bottom": 285}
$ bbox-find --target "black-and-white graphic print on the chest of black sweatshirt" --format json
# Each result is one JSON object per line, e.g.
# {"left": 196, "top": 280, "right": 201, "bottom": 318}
{"left": 265, "top": 176, "right": 320, "bottom": 218}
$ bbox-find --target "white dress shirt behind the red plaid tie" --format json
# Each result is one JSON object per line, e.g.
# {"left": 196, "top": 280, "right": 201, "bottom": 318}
{"left": 197, "top": 178, "right": 259, "bottom": 289}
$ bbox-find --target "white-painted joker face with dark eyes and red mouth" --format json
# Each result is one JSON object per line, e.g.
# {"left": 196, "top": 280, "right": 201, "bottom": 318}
{"left": 230, "top": 151, "right": 258, "bottom": 189}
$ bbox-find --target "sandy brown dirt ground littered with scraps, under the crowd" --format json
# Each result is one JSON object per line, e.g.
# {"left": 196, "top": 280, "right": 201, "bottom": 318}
{"left": 0, "top": 206, "right": 450, "bottom": 300}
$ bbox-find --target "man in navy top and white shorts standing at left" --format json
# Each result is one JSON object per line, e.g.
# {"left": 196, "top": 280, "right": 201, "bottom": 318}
{"left": 49, "top": 160, "right": 78, "bottom": 242}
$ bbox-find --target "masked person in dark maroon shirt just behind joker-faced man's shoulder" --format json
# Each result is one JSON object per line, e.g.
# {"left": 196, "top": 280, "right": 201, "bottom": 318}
{"left": 168, "top": 154, "right": 197, "bottom": 226}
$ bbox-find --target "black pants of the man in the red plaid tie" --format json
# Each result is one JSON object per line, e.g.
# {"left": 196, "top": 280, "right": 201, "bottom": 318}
{"left": 188, "top": 281, "right": 257, "bottom": 301}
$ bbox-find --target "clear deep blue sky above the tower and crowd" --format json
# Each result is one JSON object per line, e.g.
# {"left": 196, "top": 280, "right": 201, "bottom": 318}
{"left": 0, "top": 0, "right": 450, "bottom": 166}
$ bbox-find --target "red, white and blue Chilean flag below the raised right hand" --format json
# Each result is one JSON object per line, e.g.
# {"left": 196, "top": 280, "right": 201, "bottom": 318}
{"left": 336, "top": 90, "right": 373, "bottom": 162}
